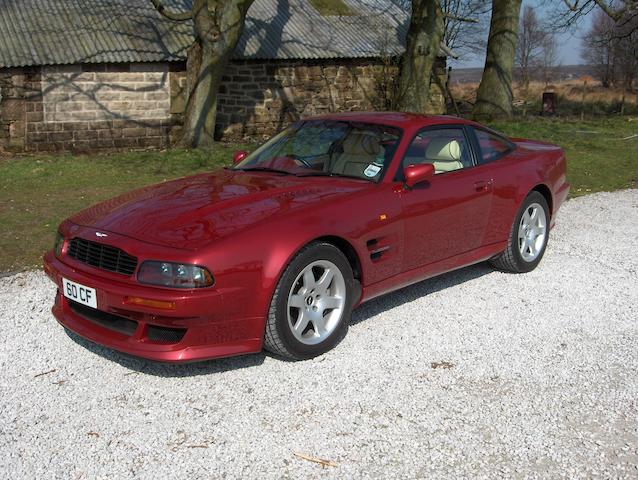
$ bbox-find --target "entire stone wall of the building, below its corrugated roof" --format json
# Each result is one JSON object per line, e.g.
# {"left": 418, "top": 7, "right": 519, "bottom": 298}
{"left": 0, "top": 59, "right": 445, "bottom": 151}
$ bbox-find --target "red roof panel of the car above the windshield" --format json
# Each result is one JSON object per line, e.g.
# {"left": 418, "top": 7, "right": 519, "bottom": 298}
{"left": 306, "top": 112, "right": 476, "bottom": 128}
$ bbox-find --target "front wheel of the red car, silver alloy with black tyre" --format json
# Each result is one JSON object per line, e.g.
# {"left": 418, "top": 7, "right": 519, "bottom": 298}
{"left": 264, "top": 242, "right": 354, "bottom": 360}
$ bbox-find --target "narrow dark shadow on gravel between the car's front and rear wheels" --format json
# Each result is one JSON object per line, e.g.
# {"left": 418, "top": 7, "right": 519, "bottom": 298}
{"left": 350, "top": 262, "right": 494, "bottom": 325}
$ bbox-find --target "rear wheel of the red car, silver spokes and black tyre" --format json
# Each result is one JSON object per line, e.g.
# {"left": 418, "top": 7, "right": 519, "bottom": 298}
{"left": 490, "top": 191, "right": 550, "bottom": 273}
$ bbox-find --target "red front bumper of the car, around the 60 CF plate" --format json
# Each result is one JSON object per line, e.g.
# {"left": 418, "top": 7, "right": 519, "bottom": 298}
{"left": 44, "top": 252, "right": 264, "bottom": 363}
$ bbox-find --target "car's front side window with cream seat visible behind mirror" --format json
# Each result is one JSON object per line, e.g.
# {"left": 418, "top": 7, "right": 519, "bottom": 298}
{"left": 403, "top": 128, "right": 472, "bottom": 174}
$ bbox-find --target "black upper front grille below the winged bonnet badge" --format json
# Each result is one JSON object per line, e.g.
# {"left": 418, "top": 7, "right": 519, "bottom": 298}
{"left": 67, "top": 237, "right": 137, "bottom": 276}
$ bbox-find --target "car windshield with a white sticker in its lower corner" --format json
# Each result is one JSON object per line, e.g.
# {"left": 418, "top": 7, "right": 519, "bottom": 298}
{"left": 234, "top": 120, "right": 401, "bottom": 182}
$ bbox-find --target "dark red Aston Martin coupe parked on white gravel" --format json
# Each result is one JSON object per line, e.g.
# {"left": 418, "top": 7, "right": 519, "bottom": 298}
{"left": 44, "top": 113, "right": 569, "bottom": 362}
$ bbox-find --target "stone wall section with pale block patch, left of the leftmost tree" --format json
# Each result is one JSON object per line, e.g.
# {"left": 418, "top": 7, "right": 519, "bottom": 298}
{"left": 0, "top": 64, "right": 174, "bottom": 151}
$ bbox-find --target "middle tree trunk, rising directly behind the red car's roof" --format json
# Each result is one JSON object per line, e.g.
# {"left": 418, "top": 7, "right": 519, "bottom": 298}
{"left": 397, "top": 0, "right": 444, "bottom": 113}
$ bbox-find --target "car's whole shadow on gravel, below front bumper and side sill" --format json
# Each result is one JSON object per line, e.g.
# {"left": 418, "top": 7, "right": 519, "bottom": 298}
{"left": 65, "top": 263, "right": 494, "bottom": 377}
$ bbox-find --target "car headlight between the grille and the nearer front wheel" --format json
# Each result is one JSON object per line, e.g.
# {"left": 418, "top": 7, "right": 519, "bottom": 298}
{"left": 137, "top": 260, "right": 215, "bottom": 288}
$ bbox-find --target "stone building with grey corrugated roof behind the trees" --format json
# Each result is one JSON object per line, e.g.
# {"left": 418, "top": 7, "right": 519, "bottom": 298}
{"left": 0, "top": 0, "right": 451, "bottom": 151}
